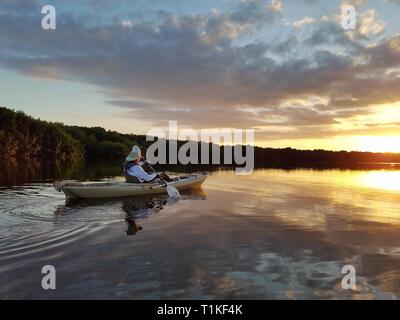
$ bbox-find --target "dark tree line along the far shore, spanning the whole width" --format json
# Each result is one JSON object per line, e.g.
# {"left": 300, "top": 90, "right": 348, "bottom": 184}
{"left": 0, "top": 107, "right": 400, "bottom": 167}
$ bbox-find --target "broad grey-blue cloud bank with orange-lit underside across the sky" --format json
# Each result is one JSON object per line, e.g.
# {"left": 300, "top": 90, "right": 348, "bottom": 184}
{"left": 0, "top": 0, "right": 400, "bottom": 138}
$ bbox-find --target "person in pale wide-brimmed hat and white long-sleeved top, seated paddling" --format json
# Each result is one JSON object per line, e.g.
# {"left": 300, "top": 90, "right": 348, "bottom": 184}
{"left": 122, "top": 146, "right": 172, "bottom": 183}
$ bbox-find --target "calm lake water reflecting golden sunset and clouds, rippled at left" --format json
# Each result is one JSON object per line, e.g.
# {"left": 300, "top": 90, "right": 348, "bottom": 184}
{"left": 0, "top": 170, "right": 400, "bottom": 299}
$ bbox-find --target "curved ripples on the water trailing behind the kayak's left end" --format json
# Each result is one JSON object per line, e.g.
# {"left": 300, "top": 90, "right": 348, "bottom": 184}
{"left": 0, "top": 184, "right": 124, "bottom": 264}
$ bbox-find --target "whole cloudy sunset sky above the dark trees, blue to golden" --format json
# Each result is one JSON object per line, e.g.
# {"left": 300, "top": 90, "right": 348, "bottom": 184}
{"left": 0, "top": 0, "right": 400, "bottom": 152}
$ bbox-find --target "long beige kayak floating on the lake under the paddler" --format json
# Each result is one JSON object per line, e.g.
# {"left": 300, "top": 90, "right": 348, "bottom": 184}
{"left": 54, "top": 173, "right": 208, "bottom": 199}
